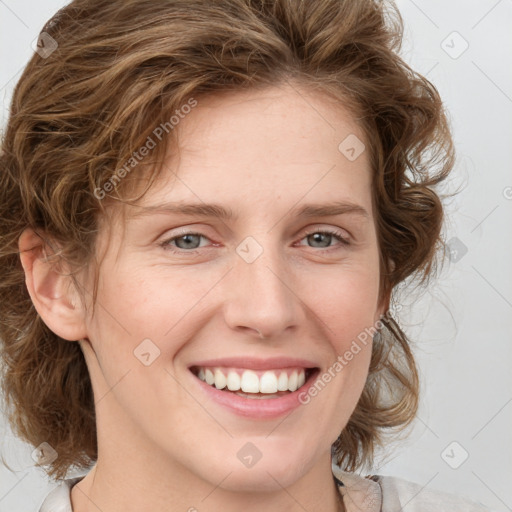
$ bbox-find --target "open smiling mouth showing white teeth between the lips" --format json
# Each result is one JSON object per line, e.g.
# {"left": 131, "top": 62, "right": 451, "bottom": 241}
{"left": 190, "top": 366, "right": 319, "bottom": 399}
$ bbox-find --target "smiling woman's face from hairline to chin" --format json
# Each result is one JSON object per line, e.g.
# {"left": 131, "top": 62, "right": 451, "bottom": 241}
{"left": 81, "top": 86, "right": 385, "bottom": 490}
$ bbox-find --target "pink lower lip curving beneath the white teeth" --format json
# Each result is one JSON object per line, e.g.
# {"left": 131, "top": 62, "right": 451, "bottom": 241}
{"left": 192, "top": 370, "right": 318, "bottom": 419}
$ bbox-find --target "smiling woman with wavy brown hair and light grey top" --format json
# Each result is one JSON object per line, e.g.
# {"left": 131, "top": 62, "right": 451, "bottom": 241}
{"left": 0, "top": 0, "right": 496, "bottom": 512}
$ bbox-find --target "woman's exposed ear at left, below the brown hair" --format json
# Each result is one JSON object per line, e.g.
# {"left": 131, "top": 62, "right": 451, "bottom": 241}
{"left": 18, "top": 228, "right": 87, "bottom": 341}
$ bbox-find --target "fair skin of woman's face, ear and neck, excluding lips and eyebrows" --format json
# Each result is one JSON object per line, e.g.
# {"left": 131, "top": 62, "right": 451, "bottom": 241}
{"left": 20, "top": 85, "right": 387, "bottom": 512}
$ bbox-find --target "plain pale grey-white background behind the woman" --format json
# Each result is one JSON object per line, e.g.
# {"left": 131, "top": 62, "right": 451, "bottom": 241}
{"left": 0, "top": 0, "right": 512, "bottom": 512}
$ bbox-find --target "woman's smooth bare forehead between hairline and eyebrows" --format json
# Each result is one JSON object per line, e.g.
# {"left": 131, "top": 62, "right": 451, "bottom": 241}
{"left": 122, "top": 85, "right": 370, "bottom": 217}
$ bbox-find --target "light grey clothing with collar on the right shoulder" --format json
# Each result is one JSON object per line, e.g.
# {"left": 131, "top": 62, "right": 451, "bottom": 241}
{"left": 333, "top": 467, "right": 492, "bottom": 512}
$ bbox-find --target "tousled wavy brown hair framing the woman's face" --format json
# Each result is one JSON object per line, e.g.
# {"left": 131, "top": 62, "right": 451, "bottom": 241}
{"left": 0, "top": 0, "right": 454, "bottom": 478}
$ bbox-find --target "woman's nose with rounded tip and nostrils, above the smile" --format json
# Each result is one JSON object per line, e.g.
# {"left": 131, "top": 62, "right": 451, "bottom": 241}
{"left": 223, "top": 239, "right": 304, "bottom": 339}
